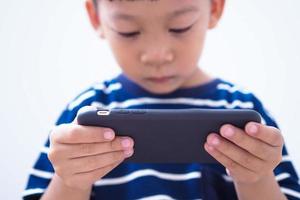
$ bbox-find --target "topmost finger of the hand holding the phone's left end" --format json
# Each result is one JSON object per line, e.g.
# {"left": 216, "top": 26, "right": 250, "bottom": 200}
{"left": 50, "top": 124, "right": 115, "bottom": 144}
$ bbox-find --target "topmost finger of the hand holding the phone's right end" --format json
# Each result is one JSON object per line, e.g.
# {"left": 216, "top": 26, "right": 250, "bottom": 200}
{"left": 245, "top": 122, "right": 284, "bottom": 147}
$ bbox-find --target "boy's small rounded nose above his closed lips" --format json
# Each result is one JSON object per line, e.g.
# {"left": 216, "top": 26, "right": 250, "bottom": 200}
{"left": 140, "top": 45, "right": 174, "bottom": 66}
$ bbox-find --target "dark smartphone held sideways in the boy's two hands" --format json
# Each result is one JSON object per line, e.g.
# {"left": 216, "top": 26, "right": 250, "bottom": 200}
{"left": 77, "top": 107, "right": 261, "bottom": 163}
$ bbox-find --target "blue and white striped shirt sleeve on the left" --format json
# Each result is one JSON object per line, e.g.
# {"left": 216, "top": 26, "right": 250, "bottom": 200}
{"left": 22, "top": 89, "right": 95, "bottom": 200}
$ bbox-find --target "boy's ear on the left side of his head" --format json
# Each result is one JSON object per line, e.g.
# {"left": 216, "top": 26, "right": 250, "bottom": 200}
{"left": 85, "top": 0, "right": 105, "bottom": 39}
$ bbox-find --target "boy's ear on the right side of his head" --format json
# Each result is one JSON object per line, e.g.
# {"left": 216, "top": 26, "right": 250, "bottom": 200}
{"left": 209, "top": 0, "right": 225, "bottom": 29}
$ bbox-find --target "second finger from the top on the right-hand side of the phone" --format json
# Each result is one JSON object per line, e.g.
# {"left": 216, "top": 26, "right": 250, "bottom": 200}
{"left": 220, "top": 125, "right": 274, "bottom": 160}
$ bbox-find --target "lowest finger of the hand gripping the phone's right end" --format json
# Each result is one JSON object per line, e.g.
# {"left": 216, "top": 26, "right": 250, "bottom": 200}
{"left": 204, "top": 143, "right": 255, "bottom": 180}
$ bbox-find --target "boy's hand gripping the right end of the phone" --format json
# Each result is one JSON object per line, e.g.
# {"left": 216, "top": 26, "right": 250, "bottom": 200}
{"left": 204, "top": 122, "right": 284, "bottom": 184}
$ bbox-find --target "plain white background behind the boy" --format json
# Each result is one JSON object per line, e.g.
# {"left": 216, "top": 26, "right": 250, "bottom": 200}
{"left": 0, "top": 0, "right": 300, "bottom": 199}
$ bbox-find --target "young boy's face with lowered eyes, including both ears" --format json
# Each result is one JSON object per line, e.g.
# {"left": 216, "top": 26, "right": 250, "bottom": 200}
{"left": 87, "top": 0, "right": 224, "bottom": 94}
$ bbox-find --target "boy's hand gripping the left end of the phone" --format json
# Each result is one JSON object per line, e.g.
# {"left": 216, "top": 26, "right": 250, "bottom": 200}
{"left": 48, "top": 120, "right": 133, "bottom": 190}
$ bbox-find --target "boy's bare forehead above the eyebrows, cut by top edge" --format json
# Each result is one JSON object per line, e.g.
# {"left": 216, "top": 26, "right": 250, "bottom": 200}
{"left": 100, "top": 0, "right": 205, "bottom": 20}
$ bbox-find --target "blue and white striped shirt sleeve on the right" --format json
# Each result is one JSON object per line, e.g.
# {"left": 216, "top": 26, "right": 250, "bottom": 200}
{"left": 254, "top": 98, "right": 300, "bottom": 200}
